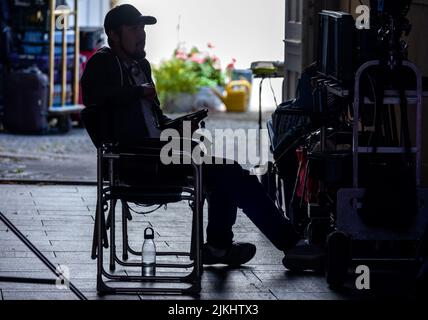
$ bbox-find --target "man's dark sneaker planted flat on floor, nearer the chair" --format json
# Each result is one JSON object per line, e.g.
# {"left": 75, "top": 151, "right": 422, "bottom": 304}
{"left": 202, "top": 242, "right": 257, "bottom": 267}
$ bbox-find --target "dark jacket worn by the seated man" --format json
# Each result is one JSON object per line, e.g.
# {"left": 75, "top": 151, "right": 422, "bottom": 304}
{"left": 81, "top": 47, "right": 169, "bottom": 145}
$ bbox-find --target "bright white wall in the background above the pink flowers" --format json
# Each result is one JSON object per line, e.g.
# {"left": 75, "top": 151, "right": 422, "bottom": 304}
{"left": 117, "top": 0, "right": 285, "bottom": 110}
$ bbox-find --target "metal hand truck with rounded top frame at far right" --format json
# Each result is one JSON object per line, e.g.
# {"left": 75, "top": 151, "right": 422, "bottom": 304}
{"left": 326, "top": 60, "right": 428, "bottom": 286}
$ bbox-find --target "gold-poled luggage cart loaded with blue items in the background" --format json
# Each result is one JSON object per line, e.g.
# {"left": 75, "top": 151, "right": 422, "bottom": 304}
{"left": 7, "top": 0, "right": 84, "bottom": 132}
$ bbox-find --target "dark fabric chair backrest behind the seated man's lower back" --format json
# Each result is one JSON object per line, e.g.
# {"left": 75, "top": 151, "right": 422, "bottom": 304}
{"left": 81, "top": 107, "right": 113, "bottom": 148}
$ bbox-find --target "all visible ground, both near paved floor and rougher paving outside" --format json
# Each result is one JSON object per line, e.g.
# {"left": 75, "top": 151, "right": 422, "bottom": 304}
{"left": 0, "top": 110, "right": 422, "bottom": 300}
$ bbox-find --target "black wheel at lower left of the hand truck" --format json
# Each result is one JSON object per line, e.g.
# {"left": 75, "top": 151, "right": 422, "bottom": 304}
{"left": 326, "top": 231, "right": 350, "bottom": 288}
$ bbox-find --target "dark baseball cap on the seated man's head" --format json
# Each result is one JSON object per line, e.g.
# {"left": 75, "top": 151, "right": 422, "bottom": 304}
{"left": 104, "top": 4, "right": 157, "bottom": 33}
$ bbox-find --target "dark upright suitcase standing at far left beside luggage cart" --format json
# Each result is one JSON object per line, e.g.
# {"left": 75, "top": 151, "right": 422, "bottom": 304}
{"left": 3, "top": 66, "right": 49, "bottom": 134}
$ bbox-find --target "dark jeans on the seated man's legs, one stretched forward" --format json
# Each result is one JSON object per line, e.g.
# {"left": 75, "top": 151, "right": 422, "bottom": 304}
{"left": 203, "top": 159, "right": 296, "bottom": 250}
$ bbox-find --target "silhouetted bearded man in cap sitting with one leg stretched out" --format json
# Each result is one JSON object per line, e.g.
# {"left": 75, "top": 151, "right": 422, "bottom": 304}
{"left": 81, "top": 5, "right": 299, "bottom": 266}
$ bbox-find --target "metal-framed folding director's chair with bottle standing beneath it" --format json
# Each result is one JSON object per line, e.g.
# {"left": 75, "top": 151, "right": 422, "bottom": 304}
{"left": 82, "top": 107, "right": 204, "bottom": 295}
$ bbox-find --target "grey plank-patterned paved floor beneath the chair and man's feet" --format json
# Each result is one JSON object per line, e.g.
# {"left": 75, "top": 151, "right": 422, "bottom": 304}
{"left": 0, "top": 185, "right": 422, "bottom": 300}
